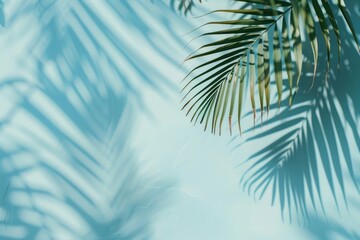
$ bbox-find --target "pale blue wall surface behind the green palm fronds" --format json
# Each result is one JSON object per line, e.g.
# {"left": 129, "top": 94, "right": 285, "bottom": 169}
{"left": 0, "top": 0, "right": 360, "bottom": 240}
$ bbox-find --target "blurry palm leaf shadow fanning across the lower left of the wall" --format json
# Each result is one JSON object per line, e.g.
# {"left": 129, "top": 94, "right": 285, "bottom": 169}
{"left": 1, "top": 75, "right": 171, "bottom": 239}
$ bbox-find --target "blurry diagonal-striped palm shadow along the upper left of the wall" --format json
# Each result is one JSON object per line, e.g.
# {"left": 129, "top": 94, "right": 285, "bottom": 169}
{"left": 8, "top": 0, "right": 176, "bottom": 99}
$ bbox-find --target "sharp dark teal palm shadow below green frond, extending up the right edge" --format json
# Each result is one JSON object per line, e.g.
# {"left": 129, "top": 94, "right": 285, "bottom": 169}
{"left": 233, "top": 2, "right": 360, "bottom": 221}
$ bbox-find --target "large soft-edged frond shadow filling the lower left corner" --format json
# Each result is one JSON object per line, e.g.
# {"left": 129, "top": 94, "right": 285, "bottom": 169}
{"left": 0, "top": 76, "right": 171, "bottom": 239}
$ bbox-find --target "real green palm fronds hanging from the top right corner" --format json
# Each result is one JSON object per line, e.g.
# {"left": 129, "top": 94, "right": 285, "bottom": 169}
{"left": 183, "top": 0, "right": 359, "bottom": 134}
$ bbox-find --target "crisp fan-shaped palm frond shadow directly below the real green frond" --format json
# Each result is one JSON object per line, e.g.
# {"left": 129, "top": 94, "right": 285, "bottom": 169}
{"left": 238, "top": 81, "right": 360, "bottom": 223}
